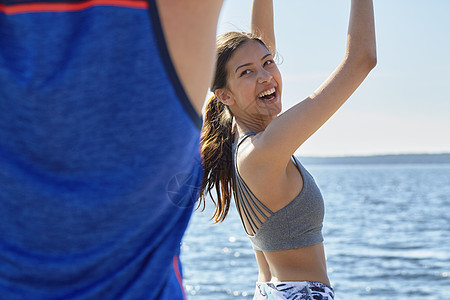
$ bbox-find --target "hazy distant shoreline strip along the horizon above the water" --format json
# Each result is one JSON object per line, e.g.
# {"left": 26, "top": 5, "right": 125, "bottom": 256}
{"left": 298, "top": 153, "right": 450, "bottom": 165}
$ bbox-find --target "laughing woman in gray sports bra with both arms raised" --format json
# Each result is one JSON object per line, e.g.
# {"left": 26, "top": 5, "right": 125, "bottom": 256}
{"left": 201, "top": 0, "right": 376, "bottom": 299}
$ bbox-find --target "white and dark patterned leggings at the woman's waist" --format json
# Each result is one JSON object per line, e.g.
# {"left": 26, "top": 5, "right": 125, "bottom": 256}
{"left": 253, "top": 281, "right": 334, "bottom": 300}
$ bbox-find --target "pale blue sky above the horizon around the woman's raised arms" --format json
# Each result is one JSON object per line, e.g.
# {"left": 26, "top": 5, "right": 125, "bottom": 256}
{"left": 218, "top": 0, "right": 450, "bottom": 156}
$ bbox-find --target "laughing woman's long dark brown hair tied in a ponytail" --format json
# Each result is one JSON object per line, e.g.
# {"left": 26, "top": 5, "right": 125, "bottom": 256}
{"left": 198, "top": 32, "right": 267, "bottom": 223}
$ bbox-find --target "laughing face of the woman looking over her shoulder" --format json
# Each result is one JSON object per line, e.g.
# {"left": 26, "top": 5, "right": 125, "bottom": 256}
{"left": 219, "top": 40, "right": 281, "bottom": 125}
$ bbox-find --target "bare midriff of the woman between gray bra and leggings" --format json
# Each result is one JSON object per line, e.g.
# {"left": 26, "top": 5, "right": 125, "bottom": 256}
{"left": 255, "top": 243, "right": 330, "bottom": 285}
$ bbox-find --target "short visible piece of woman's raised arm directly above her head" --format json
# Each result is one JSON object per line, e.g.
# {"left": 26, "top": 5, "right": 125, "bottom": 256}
{"left": 250, "top": 0, "right": 276, "bottom": 55}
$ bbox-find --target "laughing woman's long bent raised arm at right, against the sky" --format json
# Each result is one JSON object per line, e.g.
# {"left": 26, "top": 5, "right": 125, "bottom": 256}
{"left": 253, "top": 0, "right": 376, "bottom": 167}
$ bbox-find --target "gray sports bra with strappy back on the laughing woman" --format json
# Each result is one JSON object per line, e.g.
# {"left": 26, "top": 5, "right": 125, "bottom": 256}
{"left": 233, "top": 132, "right": 325, "bottom": 251}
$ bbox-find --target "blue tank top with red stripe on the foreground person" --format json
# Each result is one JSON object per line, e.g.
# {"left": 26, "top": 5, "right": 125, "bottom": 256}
{"left": 0, "top": 0, "right": 202, "bottom": 300}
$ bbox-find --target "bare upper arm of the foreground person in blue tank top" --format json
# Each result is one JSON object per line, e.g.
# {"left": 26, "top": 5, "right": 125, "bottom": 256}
{"left": 157, "top": 0, "right": 223, "bottom": 115}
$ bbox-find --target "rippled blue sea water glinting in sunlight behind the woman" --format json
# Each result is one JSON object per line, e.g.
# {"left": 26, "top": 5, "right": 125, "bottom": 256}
{"left": 181, "top": 164, "right": 450, "bottom": 300}
